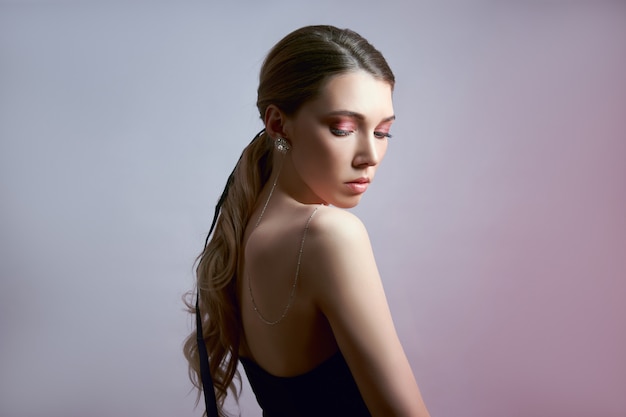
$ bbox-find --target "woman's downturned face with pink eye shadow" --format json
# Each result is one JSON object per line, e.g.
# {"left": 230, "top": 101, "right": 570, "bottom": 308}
{"left": 284, "top": 71, "right": 395, "bottom": 208}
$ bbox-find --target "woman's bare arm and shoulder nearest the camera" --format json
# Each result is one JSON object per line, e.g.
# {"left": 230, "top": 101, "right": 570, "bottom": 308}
{"left": 307, "top": 208, "right": 429, "bottom": 417}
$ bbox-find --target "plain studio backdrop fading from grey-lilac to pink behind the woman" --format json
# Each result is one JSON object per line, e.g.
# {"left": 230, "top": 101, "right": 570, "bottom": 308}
{"left": 0, "top": 0, "right": 626, "bottom": 417}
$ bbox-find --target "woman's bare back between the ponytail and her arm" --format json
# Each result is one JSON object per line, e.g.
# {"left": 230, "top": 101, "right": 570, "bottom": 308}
{"left": 238, "top": 197, "right": 352, "bottom": 376}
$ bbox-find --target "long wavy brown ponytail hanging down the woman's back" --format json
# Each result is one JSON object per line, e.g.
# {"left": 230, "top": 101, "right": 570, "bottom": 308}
{"left": 183, "top": 129, "right": 272, "bottom": 416}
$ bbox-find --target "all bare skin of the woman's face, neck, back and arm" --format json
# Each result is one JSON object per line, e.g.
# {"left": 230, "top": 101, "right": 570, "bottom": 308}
{"left": 239, "top": 71, "right": 429, "bottom": 417}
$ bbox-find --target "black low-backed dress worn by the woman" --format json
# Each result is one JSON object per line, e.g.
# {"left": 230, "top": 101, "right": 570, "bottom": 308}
{"left": 239, "top": 351, "right": 371, "bottom": 417}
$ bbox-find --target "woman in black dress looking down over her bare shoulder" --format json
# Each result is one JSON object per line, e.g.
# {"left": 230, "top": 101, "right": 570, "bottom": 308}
{"left": 184, "top": 26, "right": 428, "bottom": 417}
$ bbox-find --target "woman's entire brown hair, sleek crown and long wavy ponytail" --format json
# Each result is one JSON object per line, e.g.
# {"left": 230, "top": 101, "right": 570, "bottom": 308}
{"left": 183, "top": 26, "right": 395, "bottom": 415}
